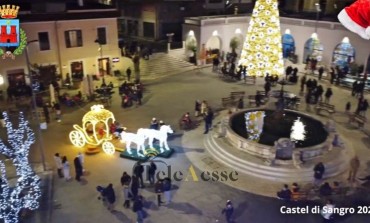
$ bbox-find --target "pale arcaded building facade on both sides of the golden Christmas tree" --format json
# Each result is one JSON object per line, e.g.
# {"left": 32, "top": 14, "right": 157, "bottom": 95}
{"left": 183, "top": 16, "right": 370, "bottom": 65}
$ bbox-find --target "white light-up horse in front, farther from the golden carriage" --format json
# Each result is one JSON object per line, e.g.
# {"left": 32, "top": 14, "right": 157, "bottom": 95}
{"left": 137, "top": 125, "right": 173, "bottom": 153}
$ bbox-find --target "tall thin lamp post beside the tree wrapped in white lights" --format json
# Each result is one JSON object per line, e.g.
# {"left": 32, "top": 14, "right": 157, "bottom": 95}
{"left": 24, "top": 40, "right": 46, "bottom": 171}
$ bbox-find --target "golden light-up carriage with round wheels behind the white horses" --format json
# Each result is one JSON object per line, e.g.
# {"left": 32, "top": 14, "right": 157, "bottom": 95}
{"left": 69, "top": 105, "right": 115, "bottom": 154}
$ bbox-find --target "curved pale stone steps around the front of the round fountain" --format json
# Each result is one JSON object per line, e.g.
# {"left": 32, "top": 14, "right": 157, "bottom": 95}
{"left": 204, "top": 134, "right": 348, "bottom": 182}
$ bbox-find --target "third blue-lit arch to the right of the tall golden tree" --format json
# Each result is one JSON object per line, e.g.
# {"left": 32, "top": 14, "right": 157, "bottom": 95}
{"left": 332, "top": 41, "right": 355, "bottom": 68}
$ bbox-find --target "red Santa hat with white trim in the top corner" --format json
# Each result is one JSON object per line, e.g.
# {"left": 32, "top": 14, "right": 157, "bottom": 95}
{"left": 338, "top": 0, "right": 370, "bottom": 39}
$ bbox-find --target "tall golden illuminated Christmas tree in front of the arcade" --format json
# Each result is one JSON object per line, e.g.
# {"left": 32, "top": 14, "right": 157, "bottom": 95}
{"left": 239, "top": 0, "right": 284, "bottom": 76}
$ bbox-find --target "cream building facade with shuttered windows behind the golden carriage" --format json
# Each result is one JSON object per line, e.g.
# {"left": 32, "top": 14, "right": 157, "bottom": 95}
{"left": 0, "top": 1, "right": 123, "bottom": 89}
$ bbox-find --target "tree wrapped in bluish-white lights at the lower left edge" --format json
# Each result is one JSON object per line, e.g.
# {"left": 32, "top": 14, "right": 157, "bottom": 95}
{"left": 0, "top": 112, "right": 41, "bottom": 223}
